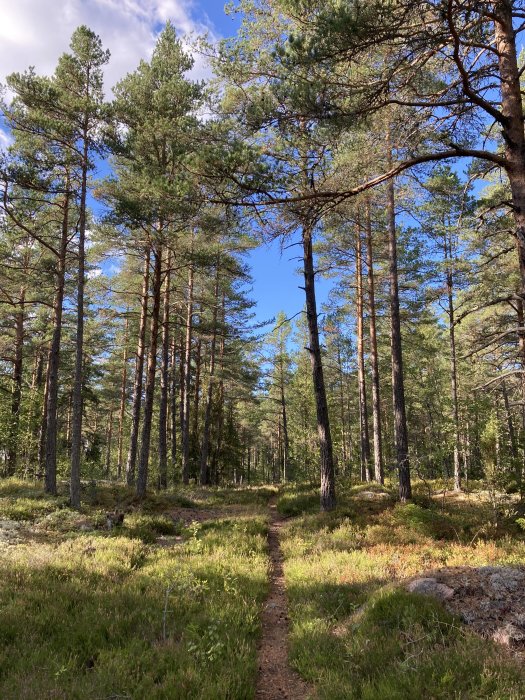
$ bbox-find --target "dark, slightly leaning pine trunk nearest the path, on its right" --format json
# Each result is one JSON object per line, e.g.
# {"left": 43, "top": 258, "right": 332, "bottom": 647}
{"left": 302, "top": 224, "right": 336, "bottom": 511}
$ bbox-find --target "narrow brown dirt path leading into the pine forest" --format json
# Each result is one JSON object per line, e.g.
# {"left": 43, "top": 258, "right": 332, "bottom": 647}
{"left": 255, "top": 504, "right": 312, "bottom": 700}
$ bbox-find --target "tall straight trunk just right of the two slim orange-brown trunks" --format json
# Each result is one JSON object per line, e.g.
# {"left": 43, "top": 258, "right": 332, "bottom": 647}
{"left": 387, "top": 144, "right": 412, "bottom": 503}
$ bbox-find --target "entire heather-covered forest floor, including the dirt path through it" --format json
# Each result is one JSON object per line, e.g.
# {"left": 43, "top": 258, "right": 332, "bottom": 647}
{"left": 0, "top": 480, "right": 525, "bottom": 700}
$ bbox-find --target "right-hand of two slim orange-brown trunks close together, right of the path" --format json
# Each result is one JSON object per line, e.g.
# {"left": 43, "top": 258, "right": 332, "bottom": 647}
{"left": 366, "top": 199, "right": 384, "bottom": 484}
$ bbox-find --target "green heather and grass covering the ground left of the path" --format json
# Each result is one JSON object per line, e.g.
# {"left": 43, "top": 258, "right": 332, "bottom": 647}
{"left": 0, "top": 482, "right": 267, "bottom": 700}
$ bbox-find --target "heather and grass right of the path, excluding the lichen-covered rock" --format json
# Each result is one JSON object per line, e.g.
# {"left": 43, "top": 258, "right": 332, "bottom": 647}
{"left": 282, "top": 485, "right": 525, "bottom": 700}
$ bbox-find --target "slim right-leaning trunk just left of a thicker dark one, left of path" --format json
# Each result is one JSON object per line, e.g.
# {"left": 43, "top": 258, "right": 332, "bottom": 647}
{"left": 126, "top": 244, "right": 151, "bottom": 486}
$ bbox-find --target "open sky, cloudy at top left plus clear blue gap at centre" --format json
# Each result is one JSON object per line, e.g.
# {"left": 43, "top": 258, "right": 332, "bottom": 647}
{"left": 0, "top": 0, "right": 328, "bottom": 330}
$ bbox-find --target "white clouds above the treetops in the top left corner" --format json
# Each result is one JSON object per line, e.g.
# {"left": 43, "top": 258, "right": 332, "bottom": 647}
{"left": 0, "top": 0, "right": 213, "bottom": 95}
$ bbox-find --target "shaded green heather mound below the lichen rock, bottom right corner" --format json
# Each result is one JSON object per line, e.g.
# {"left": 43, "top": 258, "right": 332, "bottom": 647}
{"left": 295, "top": 589, "right": 524, "bottom": 700}
